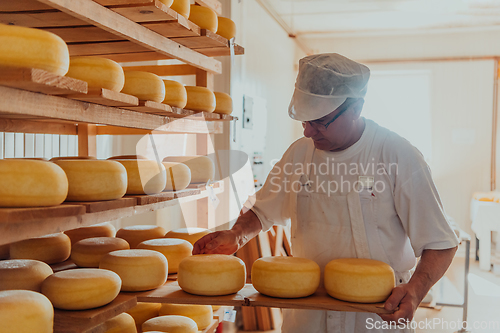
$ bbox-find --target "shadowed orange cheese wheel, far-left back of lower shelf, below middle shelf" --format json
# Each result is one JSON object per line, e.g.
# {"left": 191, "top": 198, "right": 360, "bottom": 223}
{"left": 10, "top": 233, "right": 71, "bottom": 264}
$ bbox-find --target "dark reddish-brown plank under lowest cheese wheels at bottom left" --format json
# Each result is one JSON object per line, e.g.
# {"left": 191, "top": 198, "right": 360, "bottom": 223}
{"left": 54, "top": 293, "right": 137, "bottom": 333}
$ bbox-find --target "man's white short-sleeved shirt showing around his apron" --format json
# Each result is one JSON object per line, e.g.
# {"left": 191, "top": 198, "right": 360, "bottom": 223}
{"left": 252, "top": 119, "right": 459, "bottom": 271}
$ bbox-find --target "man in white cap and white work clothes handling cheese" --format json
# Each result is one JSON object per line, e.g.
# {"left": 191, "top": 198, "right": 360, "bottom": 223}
{"left": 194, "top": 54, "right": 458, "bottom": 333}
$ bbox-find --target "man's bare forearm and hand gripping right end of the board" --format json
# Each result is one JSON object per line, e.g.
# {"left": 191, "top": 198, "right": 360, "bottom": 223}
{"left": 380, "top": 246, "right": 458, "bottom": 322}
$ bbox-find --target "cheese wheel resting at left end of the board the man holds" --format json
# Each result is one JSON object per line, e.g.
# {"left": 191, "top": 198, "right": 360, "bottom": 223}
{"left": 99, "top": 249, "right": 168, "bottom": 291}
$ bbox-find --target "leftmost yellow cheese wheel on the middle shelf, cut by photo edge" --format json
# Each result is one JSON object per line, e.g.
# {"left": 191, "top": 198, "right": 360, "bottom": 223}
{"left": 0, "top": 159, "right": 68, "bottom": 207}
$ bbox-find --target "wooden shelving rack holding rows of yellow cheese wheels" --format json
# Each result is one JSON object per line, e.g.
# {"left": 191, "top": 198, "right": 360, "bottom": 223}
{"left": 0, "top": 0, "right": 244, "bottom": 333}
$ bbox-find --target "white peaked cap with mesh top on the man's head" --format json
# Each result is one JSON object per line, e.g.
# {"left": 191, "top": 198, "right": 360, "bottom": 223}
{"left": 288, "top": 53, "right": 370, "bottom": 121}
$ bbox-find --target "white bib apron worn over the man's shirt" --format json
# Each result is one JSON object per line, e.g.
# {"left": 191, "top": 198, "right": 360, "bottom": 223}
{"left": 282, "top": 136, "right": 413, "bottom": 333}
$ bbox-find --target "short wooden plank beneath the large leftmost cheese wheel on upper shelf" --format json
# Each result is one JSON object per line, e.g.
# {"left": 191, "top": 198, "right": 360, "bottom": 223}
{"left": 0, "top": 66, "right": 87, "bottom": 95}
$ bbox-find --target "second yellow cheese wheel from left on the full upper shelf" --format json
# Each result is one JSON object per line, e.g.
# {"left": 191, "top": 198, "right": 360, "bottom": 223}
{"left": 66, "top": 57, "right": 125, "bottom": 92}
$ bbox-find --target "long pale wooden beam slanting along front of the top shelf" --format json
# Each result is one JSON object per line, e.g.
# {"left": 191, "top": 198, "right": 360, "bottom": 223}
{"left": 39, "top": 0, "right": 222, "bottom": 73}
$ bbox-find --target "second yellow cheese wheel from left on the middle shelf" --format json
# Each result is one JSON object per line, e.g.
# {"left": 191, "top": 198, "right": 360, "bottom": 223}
{"left": 54, "top": 160, "right": 127, "bottom": 201}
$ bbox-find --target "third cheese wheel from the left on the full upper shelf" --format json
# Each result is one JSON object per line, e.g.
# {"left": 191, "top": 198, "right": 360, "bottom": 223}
{"left": 122, "top": 71, "right": 165, "bottom": 103}
